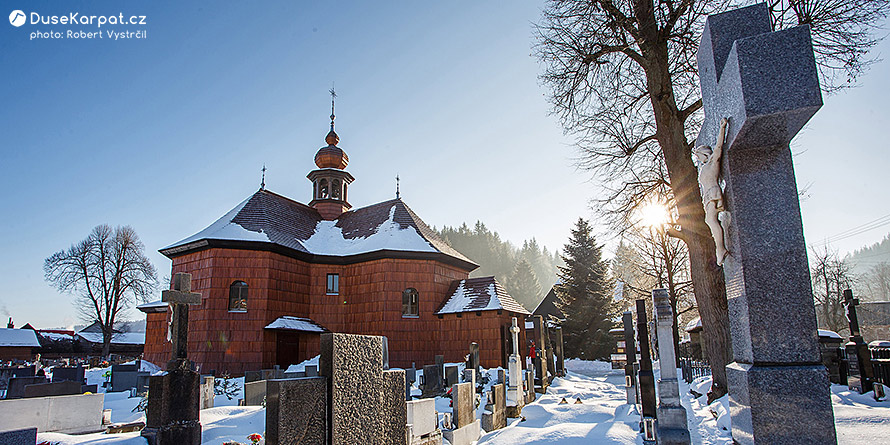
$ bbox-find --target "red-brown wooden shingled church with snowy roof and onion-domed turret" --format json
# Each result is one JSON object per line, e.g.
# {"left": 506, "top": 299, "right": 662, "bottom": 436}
{"left": 138, "top": 106, "right": 529, "bottom": 375}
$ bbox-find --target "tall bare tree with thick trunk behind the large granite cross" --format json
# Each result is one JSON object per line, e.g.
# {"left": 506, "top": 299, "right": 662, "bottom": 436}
{"left": 535, "top": 0, "right": 890, "bottom": 400}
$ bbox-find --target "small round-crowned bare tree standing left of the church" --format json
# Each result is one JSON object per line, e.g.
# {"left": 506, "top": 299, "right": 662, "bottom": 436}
{"left": 43, "top": 224, "right": 157, "bottom": 357}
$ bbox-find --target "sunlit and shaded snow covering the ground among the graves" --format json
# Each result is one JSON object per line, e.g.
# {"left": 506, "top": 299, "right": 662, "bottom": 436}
{"left": 38, "top": 358, "right": 890, "bottom": 445}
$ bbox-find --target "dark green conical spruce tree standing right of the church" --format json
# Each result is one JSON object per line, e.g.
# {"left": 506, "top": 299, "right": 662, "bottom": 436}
{"left": 556, "top": 218, "right": 613, "bottom": 360}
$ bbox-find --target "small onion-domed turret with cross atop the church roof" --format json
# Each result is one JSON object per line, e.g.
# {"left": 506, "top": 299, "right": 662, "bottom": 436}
{"left": 306, "top": 89, "right": 355, "bottom": 220}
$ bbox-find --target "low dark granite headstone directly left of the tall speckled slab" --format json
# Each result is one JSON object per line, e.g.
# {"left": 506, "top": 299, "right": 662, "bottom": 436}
{"left": 266, "top": 377, "right": 328, "bottom": 445}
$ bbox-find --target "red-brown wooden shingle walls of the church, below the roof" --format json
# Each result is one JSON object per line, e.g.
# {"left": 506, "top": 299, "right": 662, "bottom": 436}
{"left": 145, "top": 248, "right": 526, "bottom": 375}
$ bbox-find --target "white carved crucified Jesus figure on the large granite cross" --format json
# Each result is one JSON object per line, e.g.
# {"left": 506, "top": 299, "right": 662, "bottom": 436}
{"left": 692, "top": 118, "right": 729, "bottom": 266}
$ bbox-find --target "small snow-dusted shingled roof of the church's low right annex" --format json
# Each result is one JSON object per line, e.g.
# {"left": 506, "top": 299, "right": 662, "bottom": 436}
{"left": 436, "top": 277, "right": 529, "bottom": 315}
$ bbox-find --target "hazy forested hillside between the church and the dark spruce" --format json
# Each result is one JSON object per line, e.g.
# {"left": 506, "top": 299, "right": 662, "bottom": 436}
{"left": 437, "top": 221, "right": 561, "bottom": 311}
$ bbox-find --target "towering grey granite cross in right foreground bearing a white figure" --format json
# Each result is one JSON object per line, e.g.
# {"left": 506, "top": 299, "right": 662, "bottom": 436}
{"left": 697, "top": 3, "right": 837, "bottom": 444}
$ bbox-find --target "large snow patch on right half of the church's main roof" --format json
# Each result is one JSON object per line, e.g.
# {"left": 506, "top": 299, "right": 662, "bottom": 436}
{"left": 303, "top": 203, "right": 437, "bottom": 255}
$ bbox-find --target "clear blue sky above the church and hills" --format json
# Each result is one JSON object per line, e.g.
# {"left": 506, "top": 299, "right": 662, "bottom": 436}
{"left": 0, "top": 0, "right": 890, "bottom": 327}
